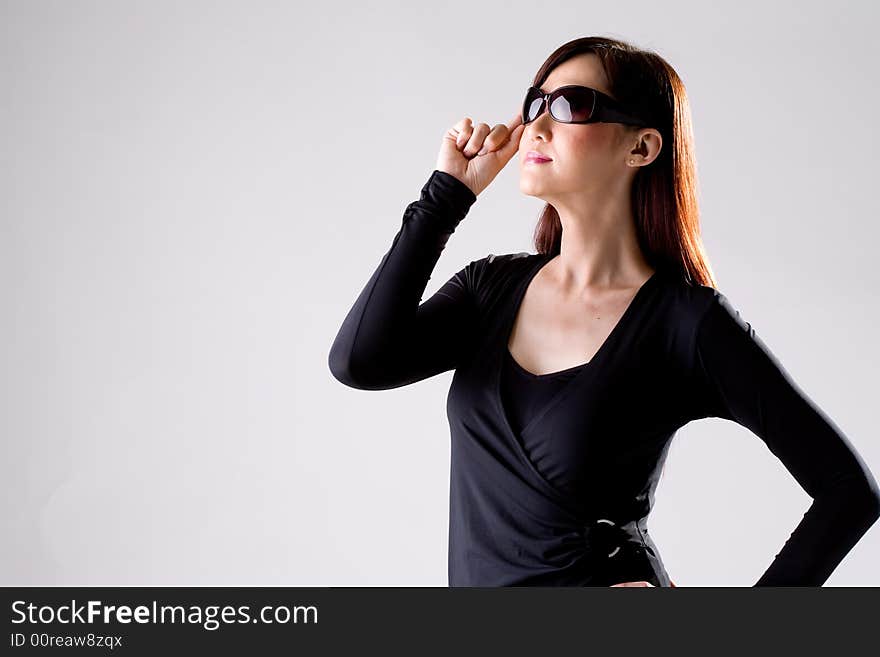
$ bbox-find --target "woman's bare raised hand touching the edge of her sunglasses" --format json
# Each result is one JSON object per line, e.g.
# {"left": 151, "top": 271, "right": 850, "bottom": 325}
{"left": 436, "top": 111, "right": 524, "bottom": 195}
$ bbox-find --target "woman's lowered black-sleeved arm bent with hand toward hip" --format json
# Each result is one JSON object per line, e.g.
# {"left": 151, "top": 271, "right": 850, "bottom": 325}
{"left": 694, "top": 290, "right": 880, "bottom": 586}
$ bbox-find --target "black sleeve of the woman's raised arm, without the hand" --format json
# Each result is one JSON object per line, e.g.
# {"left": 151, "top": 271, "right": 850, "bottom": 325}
{"left": 328, "top": 169, "right": 477, "bottom": 390}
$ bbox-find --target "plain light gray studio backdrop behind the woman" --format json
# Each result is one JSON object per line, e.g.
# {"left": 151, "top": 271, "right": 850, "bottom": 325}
{"left": 0, "top": 0, "right": 880, "bottom": 586}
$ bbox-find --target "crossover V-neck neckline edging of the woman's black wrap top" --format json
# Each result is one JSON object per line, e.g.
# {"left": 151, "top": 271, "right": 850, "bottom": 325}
{"left": 493, "top": 253, "right": 660, "bottom": 444}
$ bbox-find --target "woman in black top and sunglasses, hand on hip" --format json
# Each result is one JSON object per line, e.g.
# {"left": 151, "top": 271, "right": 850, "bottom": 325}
{"left": 329, "top": 37, "right": 880, "bottom": 586}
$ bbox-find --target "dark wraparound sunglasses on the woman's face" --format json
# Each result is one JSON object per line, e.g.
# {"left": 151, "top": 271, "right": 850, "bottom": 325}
{"left": 523, "top": 84, "right": 648, "bottom": 127}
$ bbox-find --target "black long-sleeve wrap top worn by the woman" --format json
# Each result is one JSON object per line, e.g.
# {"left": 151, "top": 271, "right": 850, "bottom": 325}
{"left": 329, "top": 170, "right": 880, "bottom": 586}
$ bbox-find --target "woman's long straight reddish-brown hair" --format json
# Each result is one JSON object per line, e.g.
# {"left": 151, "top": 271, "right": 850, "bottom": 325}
{"left": 532, "top": 36, "right": 717, "bottom": 287}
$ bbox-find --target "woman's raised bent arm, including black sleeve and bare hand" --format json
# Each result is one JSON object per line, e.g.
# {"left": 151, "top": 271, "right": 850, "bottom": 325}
{"left": 328, "top": 111, "right": 523, "bottom": 390}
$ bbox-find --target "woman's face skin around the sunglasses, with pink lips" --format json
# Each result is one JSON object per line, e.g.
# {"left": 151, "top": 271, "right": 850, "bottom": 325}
{"left": 518, "top": 53, "right": 638, "bottom": 204}
